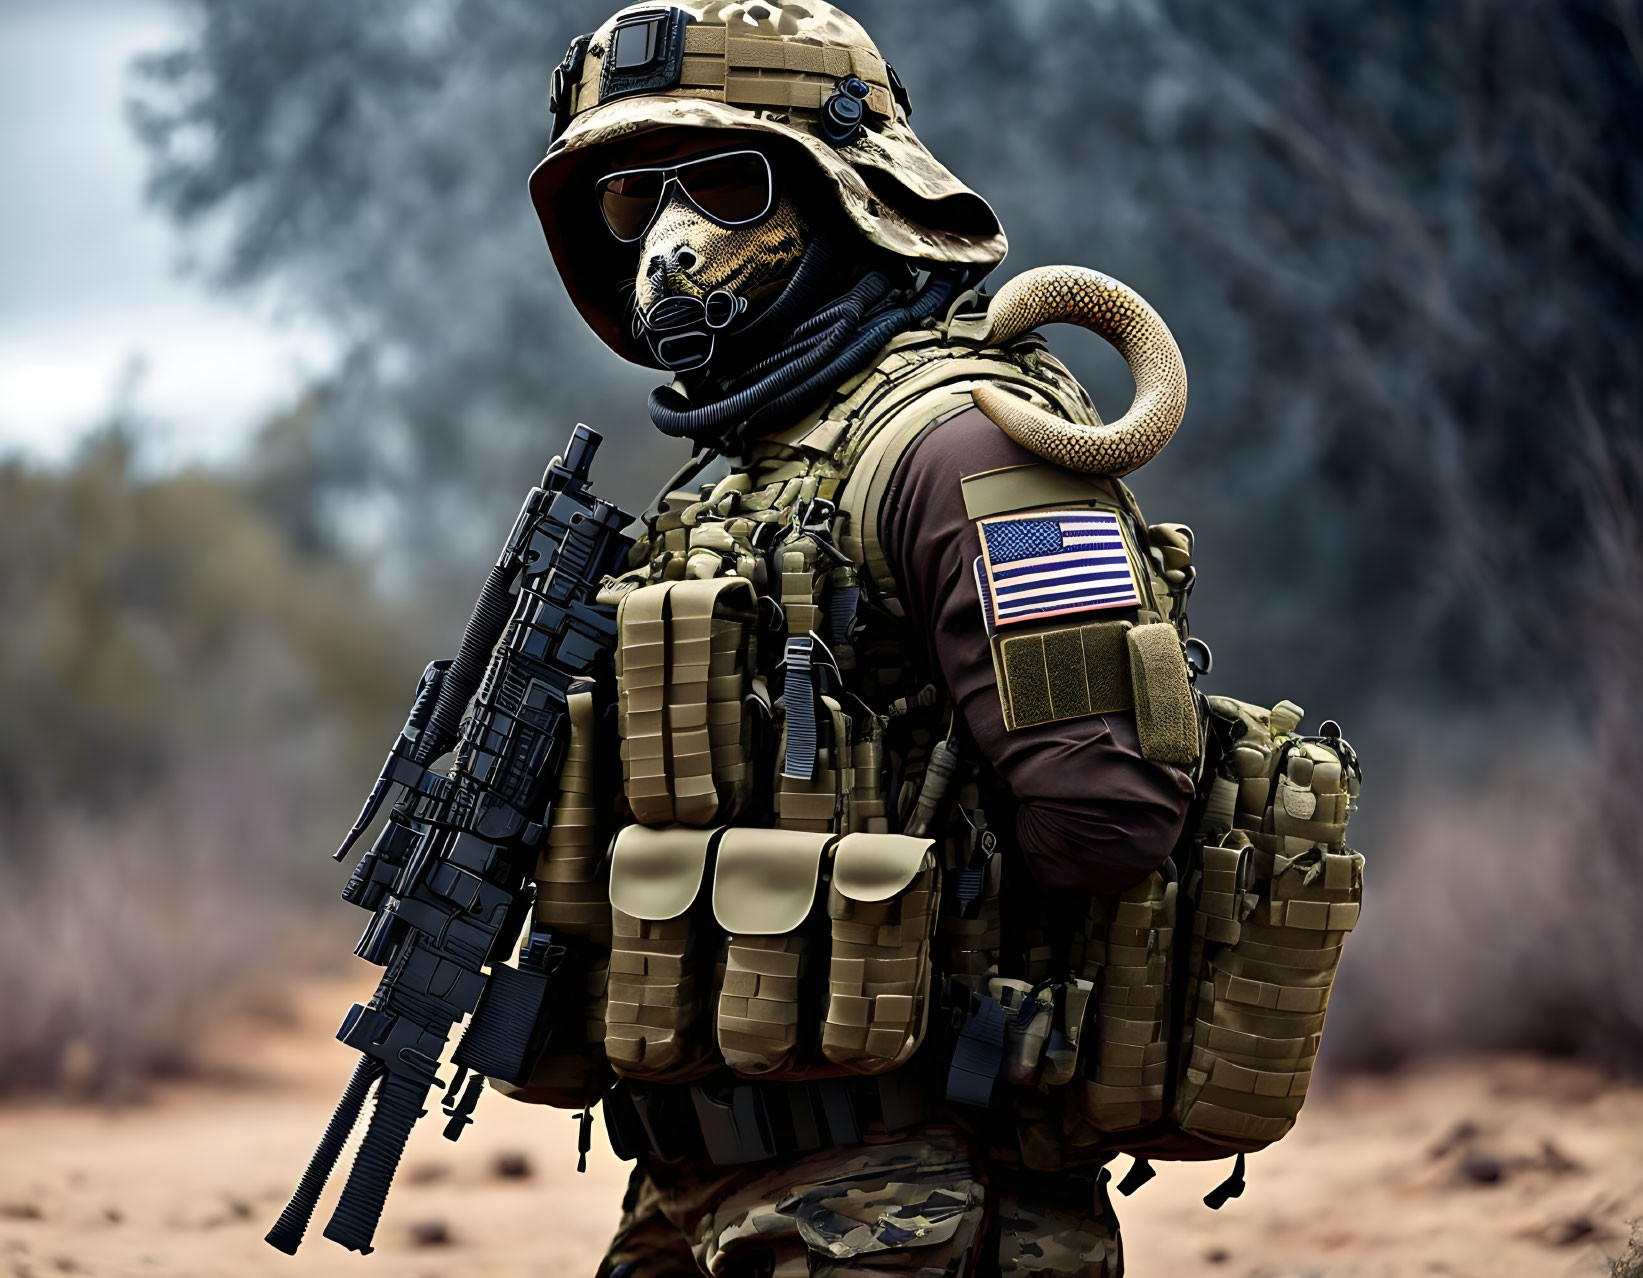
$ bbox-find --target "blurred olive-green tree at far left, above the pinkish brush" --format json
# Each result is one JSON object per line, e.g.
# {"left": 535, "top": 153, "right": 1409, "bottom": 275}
{"left": 0, "top": 422, "right": 421, "bottom": 818}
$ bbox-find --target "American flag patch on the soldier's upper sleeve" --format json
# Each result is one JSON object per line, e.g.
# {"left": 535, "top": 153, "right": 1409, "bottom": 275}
{"left": 979, "top": 509, "right": 1140, "bottom": 626}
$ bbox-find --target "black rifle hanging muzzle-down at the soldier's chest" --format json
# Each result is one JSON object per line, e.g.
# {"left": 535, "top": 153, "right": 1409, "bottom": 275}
{"left": 268, "top": 425, "right": 631, "bottom": 1255}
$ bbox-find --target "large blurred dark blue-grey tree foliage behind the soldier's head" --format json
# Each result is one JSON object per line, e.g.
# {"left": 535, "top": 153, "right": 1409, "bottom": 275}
{"left": 133, "top": 0, "right": 1643, "bottom": 713}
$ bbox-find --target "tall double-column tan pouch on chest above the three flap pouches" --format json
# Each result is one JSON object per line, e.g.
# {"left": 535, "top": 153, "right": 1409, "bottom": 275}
{"left": 616, "top": 577, "right": 757, "bottom": 826}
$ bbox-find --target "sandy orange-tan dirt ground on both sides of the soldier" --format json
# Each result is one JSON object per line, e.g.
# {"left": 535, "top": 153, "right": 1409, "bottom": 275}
{"left": 0, "top": 971, "right": 1643, "bottom": 1278}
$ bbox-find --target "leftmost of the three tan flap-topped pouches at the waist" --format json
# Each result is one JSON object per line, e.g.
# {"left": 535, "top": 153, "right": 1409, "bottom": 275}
{"left": 605, "top": 825, "right": 721, "bottom": 1083}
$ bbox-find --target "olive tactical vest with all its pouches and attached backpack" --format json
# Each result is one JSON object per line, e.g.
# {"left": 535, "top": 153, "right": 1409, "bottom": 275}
{"left": 503, "top": 285, "right": 1362, "bottom": 1170}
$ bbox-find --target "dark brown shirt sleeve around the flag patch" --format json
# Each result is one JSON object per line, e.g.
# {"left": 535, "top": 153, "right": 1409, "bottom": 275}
{"left": 881, "top": 409, "right": 1193, "bottom": 892}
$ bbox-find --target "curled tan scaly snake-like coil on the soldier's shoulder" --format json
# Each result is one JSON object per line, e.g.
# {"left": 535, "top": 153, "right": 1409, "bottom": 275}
{"left": 971, "top": 266, "right": 1186, "bottom": 475}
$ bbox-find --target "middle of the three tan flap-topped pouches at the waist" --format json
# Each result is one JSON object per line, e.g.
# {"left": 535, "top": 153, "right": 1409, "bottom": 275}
{"left": 713, "top": 830, "right": 830, "bottom": 1078}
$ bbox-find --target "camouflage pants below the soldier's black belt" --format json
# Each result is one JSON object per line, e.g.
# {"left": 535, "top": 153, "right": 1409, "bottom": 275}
{"left": 600, "top": 1129, "right": 1124, "bottom": 1278}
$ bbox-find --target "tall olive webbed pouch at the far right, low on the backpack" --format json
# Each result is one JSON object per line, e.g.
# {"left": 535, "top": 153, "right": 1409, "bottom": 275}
{"left": 1175, "top": 831, "right": 1364, "bottom": 1152}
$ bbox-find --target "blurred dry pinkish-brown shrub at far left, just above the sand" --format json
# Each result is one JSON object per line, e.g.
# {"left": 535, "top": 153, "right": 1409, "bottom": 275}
{"left": 0, "top": 795, "right": 289, "bottom": 1099}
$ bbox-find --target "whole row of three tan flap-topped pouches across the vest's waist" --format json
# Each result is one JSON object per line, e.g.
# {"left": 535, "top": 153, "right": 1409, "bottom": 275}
{"left": 605, "top": 825, "right": 940, "bottom": 1083}
